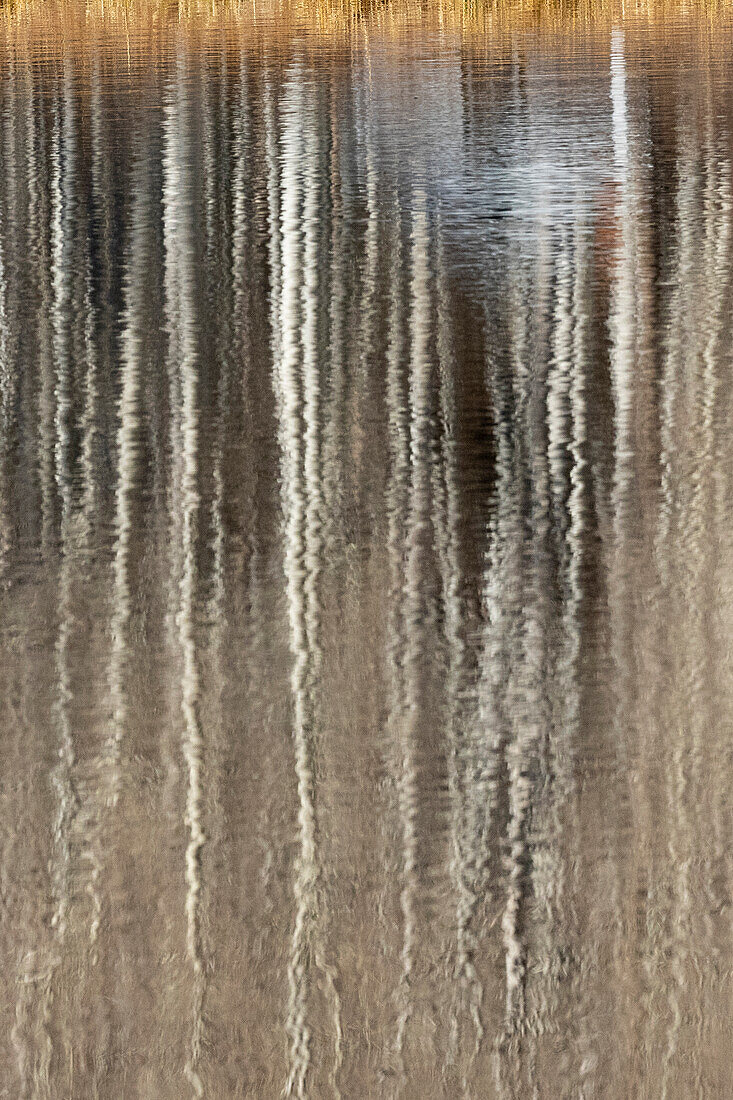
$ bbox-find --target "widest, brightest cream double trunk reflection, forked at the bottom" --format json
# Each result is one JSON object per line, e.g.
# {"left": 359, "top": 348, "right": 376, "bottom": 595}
{"left": 275, "top": 74, "right": 342, "bottom": 1097}
